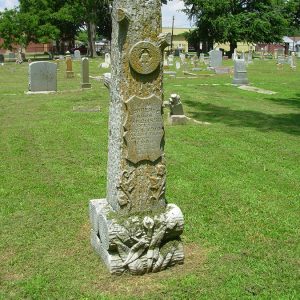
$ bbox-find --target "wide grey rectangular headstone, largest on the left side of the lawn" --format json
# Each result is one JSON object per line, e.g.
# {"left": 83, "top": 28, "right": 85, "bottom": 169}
{"left": 28, "top": 61, "right": 57, "bottom": 93}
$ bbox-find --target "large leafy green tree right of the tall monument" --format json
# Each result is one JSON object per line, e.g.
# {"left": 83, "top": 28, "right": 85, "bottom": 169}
{"left": 184, "top": 0, "right": 289, "bottom": 54}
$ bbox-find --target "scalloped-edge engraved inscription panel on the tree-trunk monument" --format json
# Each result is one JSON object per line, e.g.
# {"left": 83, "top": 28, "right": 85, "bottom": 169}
{"left": 124, "top": 95, "right": 164, "bottom": 163}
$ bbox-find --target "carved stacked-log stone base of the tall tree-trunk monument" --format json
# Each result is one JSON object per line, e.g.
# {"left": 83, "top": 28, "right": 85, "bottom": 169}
{"left": 89, "top": 199, "right": 184, "bottom": 275}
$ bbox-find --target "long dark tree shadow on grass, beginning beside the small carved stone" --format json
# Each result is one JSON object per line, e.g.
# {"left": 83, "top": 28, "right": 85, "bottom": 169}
{"left": 185, "top": 99, "right": 300, "bottom": 135}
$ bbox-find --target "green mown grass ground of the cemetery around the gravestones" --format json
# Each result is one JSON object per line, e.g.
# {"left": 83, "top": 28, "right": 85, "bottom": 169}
{"left": 0, "top": 60, "right": 300, "bottom": 299}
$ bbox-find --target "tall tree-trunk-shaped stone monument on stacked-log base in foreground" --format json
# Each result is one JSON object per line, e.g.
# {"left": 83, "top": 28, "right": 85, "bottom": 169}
{"left": 90, "top": 0, "right": 184, "bottom": 275}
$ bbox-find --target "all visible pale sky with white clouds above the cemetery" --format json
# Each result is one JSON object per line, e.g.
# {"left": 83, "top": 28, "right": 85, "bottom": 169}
{"left": 0, "top": 0, "right": 191, "bottom": 28}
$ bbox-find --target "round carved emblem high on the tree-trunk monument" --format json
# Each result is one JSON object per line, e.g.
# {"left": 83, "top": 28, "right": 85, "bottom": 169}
{"left": 129, "top": 42, "right": 161, "bottom": 75}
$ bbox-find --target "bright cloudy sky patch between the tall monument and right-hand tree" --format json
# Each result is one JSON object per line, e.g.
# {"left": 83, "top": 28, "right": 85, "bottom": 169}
{"left": 162, "top": 0, "right": 193, "bottom": 28}
